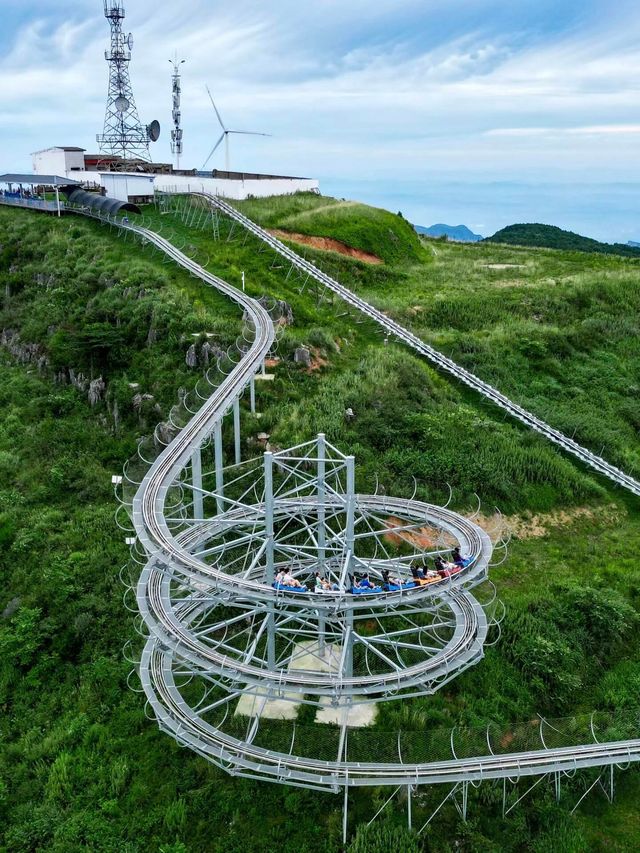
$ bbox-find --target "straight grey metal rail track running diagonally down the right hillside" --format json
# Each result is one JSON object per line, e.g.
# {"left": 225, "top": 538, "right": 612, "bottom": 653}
{"left": 201, "top": 193, "right": 640, "bottom": 496}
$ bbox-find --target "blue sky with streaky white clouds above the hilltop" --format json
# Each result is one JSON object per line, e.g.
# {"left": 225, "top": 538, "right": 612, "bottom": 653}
{"left": 0, "top": 0, "right": 640, "bottom": 241}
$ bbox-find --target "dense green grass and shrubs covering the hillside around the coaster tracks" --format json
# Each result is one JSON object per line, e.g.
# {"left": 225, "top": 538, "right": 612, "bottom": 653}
{"left": 0, "top": 201, "right": 640, "bottom": 853}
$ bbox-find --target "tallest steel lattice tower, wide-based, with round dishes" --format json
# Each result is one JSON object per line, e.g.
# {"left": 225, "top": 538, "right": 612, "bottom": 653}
{"left": 96, "top": 0, "right": 151, "bottom": 161}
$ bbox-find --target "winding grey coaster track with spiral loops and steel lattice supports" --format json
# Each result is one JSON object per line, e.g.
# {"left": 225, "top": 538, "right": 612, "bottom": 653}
{"left": 45, "top": 193, "right": 640, "bottom": 834}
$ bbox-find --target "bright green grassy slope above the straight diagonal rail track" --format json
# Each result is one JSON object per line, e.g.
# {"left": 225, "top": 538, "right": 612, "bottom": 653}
{"left": 244, "top": 202, "right": 640, "bottom": 476}
